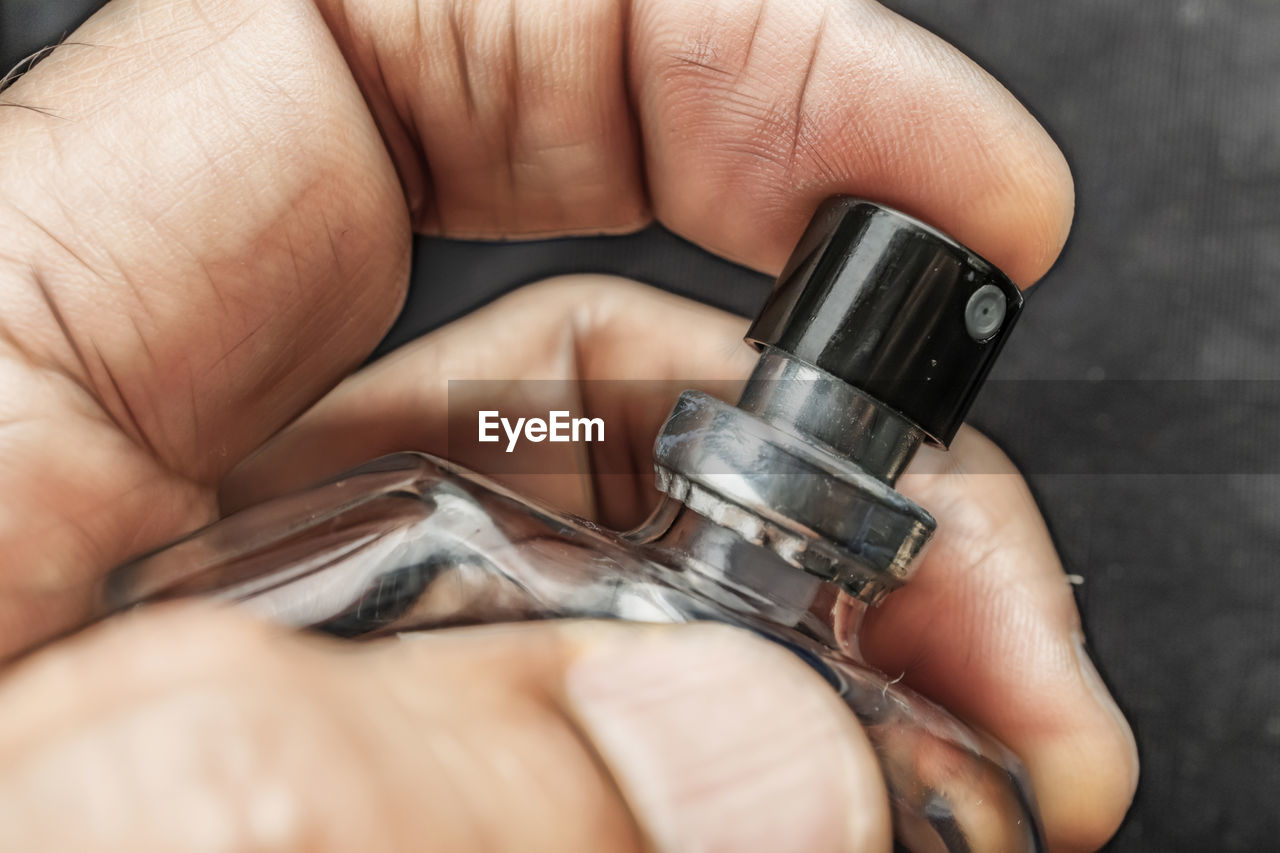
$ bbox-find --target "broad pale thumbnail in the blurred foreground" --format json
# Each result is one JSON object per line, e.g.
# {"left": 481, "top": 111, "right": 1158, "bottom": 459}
{"left": 567, "top": 626, "right": 888, "bottom": 853}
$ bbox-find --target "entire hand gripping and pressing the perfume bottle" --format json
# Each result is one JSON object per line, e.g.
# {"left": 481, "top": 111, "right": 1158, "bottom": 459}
{"left": 0, "top": 0, "right": 1137, "bottom": 850}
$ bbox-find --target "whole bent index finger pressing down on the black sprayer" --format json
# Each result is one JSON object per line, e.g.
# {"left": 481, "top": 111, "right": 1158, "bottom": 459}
{"left": 321, "top": 0, "right": 1071, "bottom": 283}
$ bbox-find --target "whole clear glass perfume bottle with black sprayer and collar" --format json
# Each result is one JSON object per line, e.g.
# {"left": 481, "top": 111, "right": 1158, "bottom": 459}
{"left": 99, "top": 197, "right": 1043, "bottom": 853}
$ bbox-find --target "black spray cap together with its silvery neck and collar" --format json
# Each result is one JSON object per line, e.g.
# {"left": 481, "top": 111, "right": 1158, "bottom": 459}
{"left": 654, "top": 197, "right": 1023, "bottom": 602}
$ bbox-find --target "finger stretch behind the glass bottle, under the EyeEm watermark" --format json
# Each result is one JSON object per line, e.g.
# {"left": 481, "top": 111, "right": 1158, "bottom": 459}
{"left": 223, "top": 275, "right": 755, "bottom": 526}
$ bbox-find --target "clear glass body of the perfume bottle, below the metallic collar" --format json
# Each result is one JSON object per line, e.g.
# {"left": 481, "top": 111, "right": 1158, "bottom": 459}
{"left": 100, "top": 453, "right": 1043, "bottom": 853}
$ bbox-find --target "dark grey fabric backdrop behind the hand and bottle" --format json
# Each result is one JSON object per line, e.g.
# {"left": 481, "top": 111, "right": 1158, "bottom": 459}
{"left": 0, "top": 0, "right": 1280, "bottom": 850}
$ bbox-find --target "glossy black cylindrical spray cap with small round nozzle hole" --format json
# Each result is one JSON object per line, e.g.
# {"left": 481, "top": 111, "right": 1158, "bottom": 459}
{"left": 746, "top": 197, "right": 1023, "bottom": 446}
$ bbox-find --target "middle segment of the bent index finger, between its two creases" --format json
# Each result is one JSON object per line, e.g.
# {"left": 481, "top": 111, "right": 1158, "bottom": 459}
{"left": 385, "top": 0, "right": 644, "bottom": 230}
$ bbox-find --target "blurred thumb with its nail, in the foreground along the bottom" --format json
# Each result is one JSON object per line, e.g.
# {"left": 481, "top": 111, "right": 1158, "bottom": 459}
{"left": 0, "top": 608, "right": 890, "bottom": 853}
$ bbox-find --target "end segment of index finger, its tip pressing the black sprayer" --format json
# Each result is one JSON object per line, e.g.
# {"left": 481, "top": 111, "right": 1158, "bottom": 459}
{"left": 632, "top": 0, "right": 1073, "bottom": 284}
